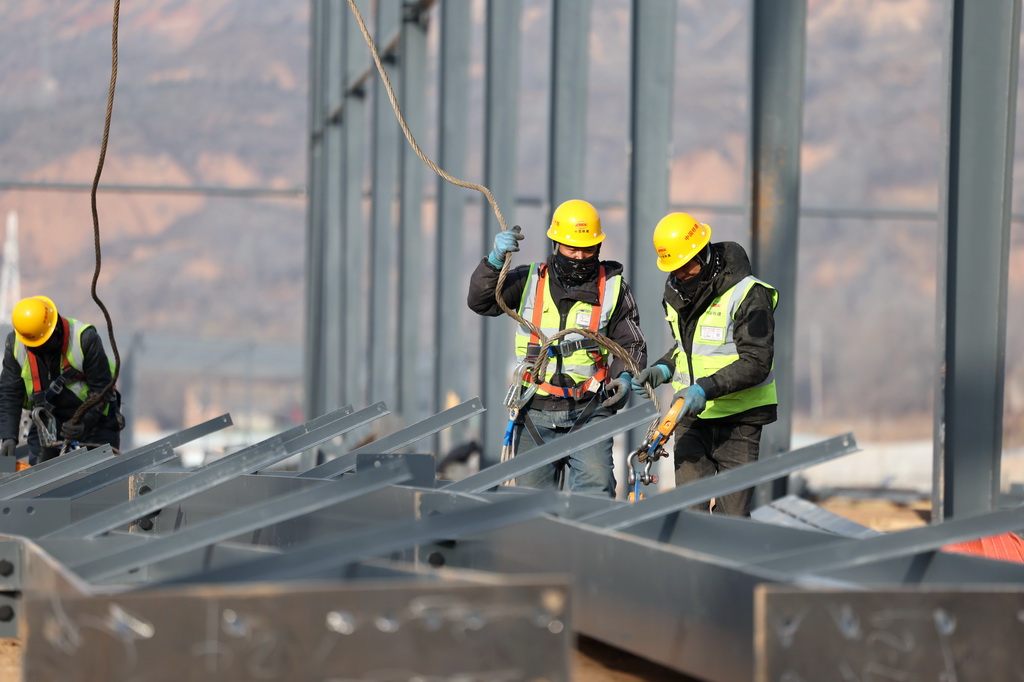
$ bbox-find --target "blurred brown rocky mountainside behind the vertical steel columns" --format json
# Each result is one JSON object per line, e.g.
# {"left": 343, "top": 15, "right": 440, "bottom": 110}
{"left": 0, "top": 0, "right": 1024, "bottom": 439}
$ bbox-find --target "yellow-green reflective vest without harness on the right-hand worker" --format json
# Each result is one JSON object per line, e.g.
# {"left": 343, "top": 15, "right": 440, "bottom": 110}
{"left": 665, "top": 275, "right": 778, "bottom": 419}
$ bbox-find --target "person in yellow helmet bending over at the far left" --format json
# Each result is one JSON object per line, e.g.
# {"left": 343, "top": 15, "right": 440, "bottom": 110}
{"left": 0, "top": 296, "right": 124, "bottom": 463}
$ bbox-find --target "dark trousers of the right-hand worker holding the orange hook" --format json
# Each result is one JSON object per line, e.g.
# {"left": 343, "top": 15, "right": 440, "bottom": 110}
{"left": 675, "top": 419, "right": 761, "bottom": 516}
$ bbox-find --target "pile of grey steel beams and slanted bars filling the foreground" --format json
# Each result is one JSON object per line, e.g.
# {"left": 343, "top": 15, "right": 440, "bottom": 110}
{"left": 0, "top": 400, "right": 1024, "bottom": 682}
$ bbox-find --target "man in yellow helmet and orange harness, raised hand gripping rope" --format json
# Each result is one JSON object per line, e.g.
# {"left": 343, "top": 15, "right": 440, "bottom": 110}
{"left": 468, "top": 200, "right": 647, "bottom": 497}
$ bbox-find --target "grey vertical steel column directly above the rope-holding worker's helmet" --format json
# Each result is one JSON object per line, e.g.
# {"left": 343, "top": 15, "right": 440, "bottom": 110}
{"left": 545, "top": 0, "right": 590, "bottom": 210}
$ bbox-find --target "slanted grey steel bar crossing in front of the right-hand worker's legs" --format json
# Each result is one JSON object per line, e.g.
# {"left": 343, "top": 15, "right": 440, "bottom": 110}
{"left": 582, "top": 433, "right": 859, "bottom": 530}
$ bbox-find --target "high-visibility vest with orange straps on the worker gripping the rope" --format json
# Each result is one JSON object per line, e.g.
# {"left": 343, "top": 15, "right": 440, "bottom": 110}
{"left": 515, "top": 263, "right": 623, "bottom": 399}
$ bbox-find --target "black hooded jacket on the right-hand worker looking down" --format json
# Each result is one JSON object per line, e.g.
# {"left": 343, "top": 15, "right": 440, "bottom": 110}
{"left": 657, "top": 242, "right": 778, "bottom": 424}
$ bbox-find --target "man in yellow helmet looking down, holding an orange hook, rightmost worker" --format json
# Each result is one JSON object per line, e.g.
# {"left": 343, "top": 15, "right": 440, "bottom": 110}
{"left": 632, "top": 213, "right": 778, "bottom": 516}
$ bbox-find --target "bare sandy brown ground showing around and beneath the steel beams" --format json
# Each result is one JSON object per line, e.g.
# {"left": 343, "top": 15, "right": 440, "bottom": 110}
{"left": 0, "top": 497, "right": 930, "bottom": 682}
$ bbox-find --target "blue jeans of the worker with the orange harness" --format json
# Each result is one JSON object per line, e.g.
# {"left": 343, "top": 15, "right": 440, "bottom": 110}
{"left": 515, "top": 398, "right": 615, "bottom": 498}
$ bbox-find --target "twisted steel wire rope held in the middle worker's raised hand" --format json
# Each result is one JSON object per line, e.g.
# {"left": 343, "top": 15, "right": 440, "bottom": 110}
{"left": 348, "top": 0, "right": 660, "bottom": 446}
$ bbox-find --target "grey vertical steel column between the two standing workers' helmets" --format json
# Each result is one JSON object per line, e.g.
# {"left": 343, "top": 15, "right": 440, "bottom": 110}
{"left": 626, "top": 0, "right": 676, "bottom": 452}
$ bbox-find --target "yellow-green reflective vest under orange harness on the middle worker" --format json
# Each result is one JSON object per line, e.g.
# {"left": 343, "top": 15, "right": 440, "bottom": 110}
{"left": 515, "top": 263, "right": 623, "bottom": 397}
